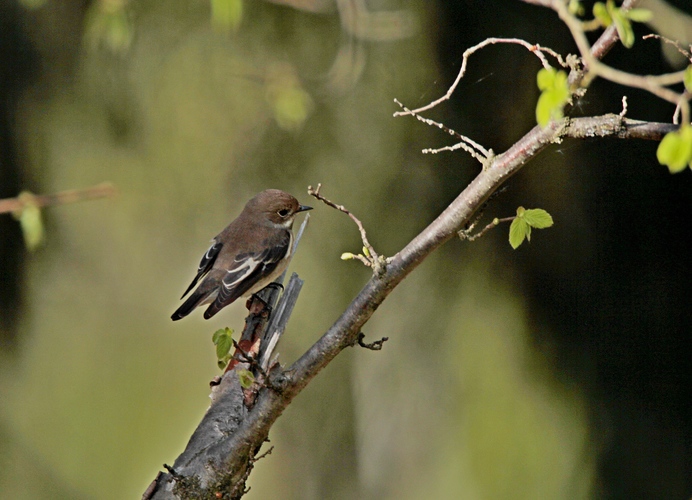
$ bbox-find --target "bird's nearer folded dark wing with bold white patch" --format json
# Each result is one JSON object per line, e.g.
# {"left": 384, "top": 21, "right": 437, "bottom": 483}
{"left": 204, "top": 231, "right": 291, "bottom": 318}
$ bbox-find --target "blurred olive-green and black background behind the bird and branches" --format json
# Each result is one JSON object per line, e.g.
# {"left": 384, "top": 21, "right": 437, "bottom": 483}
{"left": 0, "top": 0, "right": 692, "bottom": 499}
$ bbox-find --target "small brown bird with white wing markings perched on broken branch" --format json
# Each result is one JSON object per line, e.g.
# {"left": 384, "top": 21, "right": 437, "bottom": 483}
{"left": 171, "top": 189, "right": 312, "bottom": 321}
